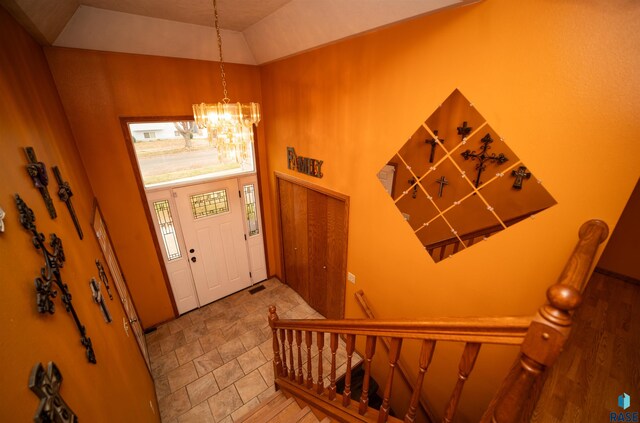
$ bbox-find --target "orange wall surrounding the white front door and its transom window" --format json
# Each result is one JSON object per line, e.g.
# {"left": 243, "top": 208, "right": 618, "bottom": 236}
{"left": 46, "top": 48, "right": 274, "bottom": 327}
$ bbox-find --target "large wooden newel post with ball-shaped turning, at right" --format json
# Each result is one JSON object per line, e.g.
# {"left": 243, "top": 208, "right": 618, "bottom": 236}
{"left": 483, "top": 220, "right": 609, "bottom": 423}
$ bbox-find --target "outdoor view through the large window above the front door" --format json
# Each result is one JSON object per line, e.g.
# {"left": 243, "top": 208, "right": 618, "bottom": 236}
{"left": 129, "top": 121, "right": 255, "bottom": 188}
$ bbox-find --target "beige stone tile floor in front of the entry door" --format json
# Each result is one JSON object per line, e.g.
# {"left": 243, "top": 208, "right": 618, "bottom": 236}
{"left": 146, "top": 279, "right": 357, "bottom": 423}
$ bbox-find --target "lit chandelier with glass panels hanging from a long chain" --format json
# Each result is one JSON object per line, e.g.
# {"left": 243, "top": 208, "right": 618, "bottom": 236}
{"left": 193, "top": 0, "right": 260, "bottom": 161}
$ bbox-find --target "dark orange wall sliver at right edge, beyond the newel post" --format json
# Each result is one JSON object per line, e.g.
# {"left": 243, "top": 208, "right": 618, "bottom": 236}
{"left": 598, "top": 181, "right": 640, "bottom": 280}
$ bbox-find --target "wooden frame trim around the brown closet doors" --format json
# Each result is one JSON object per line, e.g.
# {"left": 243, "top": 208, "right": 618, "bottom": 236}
{"left": 273, "top": 171, "right": 349, "bottom": 317}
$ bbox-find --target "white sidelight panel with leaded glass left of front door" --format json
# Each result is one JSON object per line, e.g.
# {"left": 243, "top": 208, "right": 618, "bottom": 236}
{"left": 147, "top": 189, "right": 200, "bottom": 314}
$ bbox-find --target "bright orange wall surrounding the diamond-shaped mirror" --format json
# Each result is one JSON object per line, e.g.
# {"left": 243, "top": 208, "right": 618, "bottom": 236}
{"left": 261, "top": 0, "right": 640, "bottom": 422}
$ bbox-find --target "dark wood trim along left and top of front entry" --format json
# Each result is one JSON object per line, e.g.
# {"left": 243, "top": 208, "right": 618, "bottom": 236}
{"left": 120, "top": 116, "right": 182, "bottom": 317}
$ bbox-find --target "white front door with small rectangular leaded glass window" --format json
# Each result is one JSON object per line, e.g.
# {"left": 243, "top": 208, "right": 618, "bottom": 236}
{"left": 173, "top": 178, "right": 251, "bottom": 306}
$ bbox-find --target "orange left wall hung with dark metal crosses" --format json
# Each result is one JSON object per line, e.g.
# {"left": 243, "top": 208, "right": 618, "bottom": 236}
{"left": 0, "top": 7, "right": 160, "bottom": 422}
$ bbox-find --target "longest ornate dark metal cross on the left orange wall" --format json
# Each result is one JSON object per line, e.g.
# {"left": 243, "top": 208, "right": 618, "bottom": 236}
{"left": 15, "top": 194, "right": 96, "bottom": 364}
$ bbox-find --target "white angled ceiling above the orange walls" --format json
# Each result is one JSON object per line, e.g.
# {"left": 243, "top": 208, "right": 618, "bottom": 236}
{"left": 0, "top": 0, "right": 479, "bottom": 64}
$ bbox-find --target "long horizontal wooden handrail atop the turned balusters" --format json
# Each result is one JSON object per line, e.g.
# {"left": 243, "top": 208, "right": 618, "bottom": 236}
{"left": 273, "top": 317, "right": 531, "bottom": 345}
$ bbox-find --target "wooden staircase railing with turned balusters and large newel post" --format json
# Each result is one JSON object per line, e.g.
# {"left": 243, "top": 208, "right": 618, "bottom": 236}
{"left": 269, "top": 220, "right": 608, "bottom": 423}
